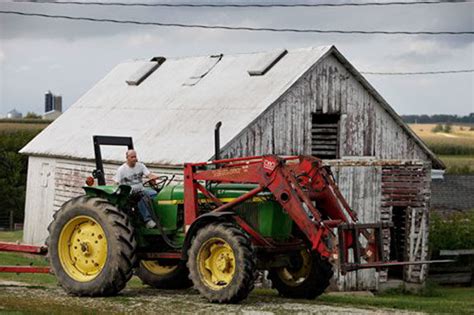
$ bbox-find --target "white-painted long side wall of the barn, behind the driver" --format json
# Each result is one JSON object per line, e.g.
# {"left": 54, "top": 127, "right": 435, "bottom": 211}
{"left": 23, "top": 156, "right": 182, "bottom": 244}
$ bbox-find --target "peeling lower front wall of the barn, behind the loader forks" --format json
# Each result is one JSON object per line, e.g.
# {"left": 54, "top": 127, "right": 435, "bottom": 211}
{"left": 326, "top": 160, "right": 431, "bottom": 290}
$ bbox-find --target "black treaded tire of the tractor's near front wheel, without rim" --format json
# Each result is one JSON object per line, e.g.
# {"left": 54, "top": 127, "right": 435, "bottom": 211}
{"left": 187, "top": 222, "right": 257, "bottom": 303}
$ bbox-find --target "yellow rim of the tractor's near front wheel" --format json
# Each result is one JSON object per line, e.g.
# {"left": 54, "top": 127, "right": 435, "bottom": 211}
{"left": 197, "top": 237, "right": 235, "bottom": 290}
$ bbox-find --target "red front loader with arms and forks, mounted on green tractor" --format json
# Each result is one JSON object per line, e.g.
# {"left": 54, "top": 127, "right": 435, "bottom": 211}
{"left": 184, "top": 155, "right": 436, "bottom": 273}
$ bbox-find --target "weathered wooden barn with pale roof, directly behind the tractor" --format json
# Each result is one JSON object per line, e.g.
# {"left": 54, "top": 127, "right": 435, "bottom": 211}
{"left": 21, "top": 46, "right": 444, "bottom": 289}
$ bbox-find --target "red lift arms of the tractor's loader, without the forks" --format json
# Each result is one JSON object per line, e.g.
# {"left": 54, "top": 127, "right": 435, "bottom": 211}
{"left": 184, "top": 155, "right": 350, "bottom": 257}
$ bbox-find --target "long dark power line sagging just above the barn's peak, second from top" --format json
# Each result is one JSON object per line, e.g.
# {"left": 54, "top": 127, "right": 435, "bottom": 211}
{"left": 0, "top": 10, "right": 474, "bottom": 35}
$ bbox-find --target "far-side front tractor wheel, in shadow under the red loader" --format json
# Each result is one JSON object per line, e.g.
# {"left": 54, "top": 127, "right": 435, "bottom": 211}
{"left": 268, "top": 249, "right": 334, "bottom": 299}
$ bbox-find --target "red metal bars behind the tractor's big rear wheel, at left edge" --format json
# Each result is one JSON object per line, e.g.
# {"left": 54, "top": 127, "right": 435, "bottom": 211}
{"left": 0, "top": 242, "right": 50, "bottom": 273}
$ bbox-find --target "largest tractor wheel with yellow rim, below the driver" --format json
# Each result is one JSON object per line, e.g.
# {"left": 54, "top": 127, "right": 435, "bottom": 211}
{"left": 47, "top": 196, "right": 136, "bottom": 296}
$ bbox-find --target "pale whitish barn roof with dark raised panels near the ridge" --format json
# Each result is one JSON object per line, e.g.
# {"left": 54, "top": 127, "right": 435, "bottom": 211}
{"left": 20, "top": 46, "right": 442, "bottom": 169}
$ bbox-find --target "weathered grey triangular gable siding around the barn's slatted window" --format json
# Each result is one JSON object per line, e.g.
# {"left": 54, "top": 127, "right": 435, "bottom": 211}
{"left": 223, "top": 56, "right": 428, "bottom": 160}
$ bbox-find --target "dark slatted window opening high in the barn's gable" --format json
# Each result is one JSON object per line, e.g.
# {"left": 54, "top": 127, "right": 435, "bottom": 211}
{"left": 311, "top": 113, "right": 340, "bottom": 159}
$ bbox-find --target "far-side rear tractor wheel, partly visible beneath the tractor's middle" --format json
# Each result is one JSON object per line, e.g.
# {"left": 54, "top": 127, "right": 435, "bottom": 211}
{"left": 136, "top": 260, "right": 193, "bottom": 289}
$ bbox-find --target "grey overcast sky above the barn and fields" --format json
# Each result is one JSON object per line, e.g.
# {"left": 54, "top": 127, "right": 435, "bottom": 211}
{"left": 0, "top": 0, "right": 474, "bottom": 116}
